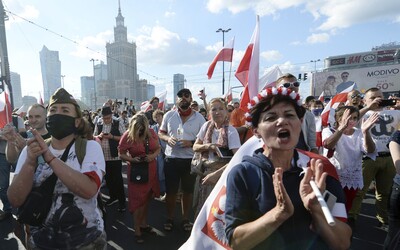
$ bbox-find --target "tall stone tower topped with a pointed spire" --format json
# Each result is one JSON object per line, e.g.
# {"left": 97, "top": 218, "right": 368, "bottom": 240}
{"left": 106, "top": 1, "right": 141, "bottom": 103}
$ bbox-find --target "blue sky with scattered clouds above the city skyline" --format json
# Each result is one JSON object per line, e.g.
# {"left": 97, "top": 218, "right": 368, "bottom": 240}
{"left": 3, "top": 0, "right": 400, "bottom": 102}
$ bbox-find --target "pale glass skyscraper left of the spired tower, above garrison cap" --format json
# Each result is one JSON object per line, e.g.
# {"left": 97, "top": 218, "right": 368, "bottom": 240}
{"left": 39, "top": 45, "right": 61, "bottom": 102}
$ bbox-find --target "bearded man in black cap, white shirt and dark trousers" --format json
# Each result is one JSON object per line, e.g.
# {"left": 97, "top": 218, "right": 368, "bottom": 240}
{"left": 158, "top": 89, "right": 205, "bottom": 232}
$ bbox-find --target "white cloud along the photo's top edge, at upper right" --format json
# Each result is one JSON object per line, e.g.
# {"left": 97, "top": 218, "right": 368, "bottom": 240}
{"left": 207, "top": 0, "right": 400, "bottom": 31}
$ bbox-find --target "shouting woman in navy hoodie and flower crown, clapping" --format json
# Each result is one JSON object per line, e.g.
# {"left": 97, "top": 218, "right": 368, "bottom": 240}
{"left": 225, "top": 87, "right": 351, "bottom": 249}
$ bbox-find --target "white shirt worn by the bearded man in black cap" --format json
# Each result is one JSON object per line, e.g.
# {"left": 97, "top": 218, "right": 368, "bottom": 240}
{"left": 160, "top": 110, "right": 206, "bottom": 159}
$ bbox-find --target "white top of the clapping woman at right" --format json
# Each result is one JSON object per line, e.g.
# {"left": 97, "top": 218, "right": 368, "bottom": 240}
{"left": 322, "top": 128, "right": 377, "bottom": 189}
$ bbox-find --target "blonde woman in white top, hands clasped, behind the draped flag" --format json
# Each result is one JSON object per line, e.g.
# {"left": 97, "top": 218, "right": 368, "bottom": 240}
{"left": 193, "top": 98, "right": 240, "bottom": 215}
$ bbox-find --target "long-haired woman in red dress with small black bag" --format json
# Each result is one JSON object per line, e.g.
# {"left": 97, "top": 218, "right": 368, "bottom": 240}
{"left": 118, "top": 113, "right": 160, "bottom": 243}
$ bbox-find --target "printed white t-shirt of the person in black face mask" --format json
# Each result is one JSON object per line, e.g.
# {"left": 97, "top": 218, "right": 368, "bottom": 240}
{"left": 15, "top": 140, "right": 105, "bottom": 246}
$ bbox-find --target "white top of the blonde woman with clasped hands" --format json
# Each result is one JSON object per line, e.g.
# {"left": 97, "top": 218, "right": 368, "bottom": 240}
{"left": 197, "top": 122, "right": 241, "bottom": 161}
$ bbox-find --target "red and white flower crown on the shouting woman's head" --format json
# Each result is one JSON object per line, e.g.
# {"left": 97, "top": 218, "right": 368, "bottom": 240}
{"left": 245, "top": 87, "right": 302, "bottom": 126}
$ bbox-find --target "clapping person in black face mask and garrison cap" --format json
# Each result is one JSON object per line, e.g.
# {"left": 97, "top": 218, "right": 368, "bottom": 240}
{"left": 7, "top": 88, "right": 107, "bottom": 249}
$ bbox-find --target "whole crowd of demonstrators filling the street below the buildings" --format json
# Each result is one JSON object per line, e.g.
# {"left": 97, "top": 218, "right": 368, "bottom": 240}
{"left": 0, "top": 74, "right": 400, "bottom": 249}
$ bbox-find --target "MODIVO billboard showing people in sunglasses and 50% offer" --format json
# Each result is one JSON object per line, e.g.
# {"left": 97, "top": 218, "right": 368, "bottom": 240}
{"left": 311, "top": 64, "right": 400, "bottom": 96}
